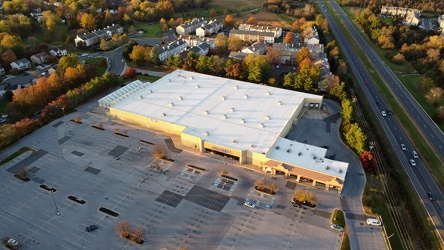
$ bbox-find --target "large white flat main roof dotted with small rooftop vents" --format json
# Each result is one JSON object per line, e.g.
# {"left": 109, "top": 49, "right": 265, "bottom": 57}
{"left": 105, "top": 70, "right": 322, "bottom": 153}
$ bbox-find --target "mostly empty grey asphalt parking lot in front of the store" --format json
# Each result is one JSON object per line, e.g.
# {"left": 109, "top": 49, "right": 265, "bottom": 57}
{"left": 0, "top": 98, "right": 350, "bottom": 249}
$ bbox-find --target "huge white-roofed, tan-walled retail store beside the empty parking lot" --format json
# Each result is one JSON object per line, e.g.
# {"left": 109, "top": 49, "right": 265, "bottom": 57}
{"left": 99, "top": 70, "right": 348, "bottom": 192}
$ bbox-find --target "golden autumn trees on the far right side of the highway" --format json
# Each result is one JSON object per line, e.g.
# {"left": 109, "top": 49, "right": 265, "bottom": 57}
{"left": 346, "top": 5, "right": 444, "bottom": 123}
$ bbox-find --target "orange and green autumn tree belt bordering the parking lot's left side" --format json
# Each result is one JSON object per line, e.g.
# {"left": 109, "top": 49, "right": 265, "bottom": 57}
{"left": 0, "top": 54, "right": 119, "bottom": 150}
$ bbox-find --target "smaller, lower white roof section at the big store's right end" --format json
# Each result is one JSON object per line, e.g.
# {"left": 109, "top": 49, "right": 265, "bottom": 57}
{"left": 267, "top": 138, "right": 348, "bottom": 180}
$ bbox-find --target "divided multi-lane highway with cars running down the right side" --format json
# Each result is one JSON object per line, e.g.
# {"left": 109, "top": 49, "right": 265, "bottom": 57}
{"left": 318, "top": 1, "right": 444, "bottom": 246}
